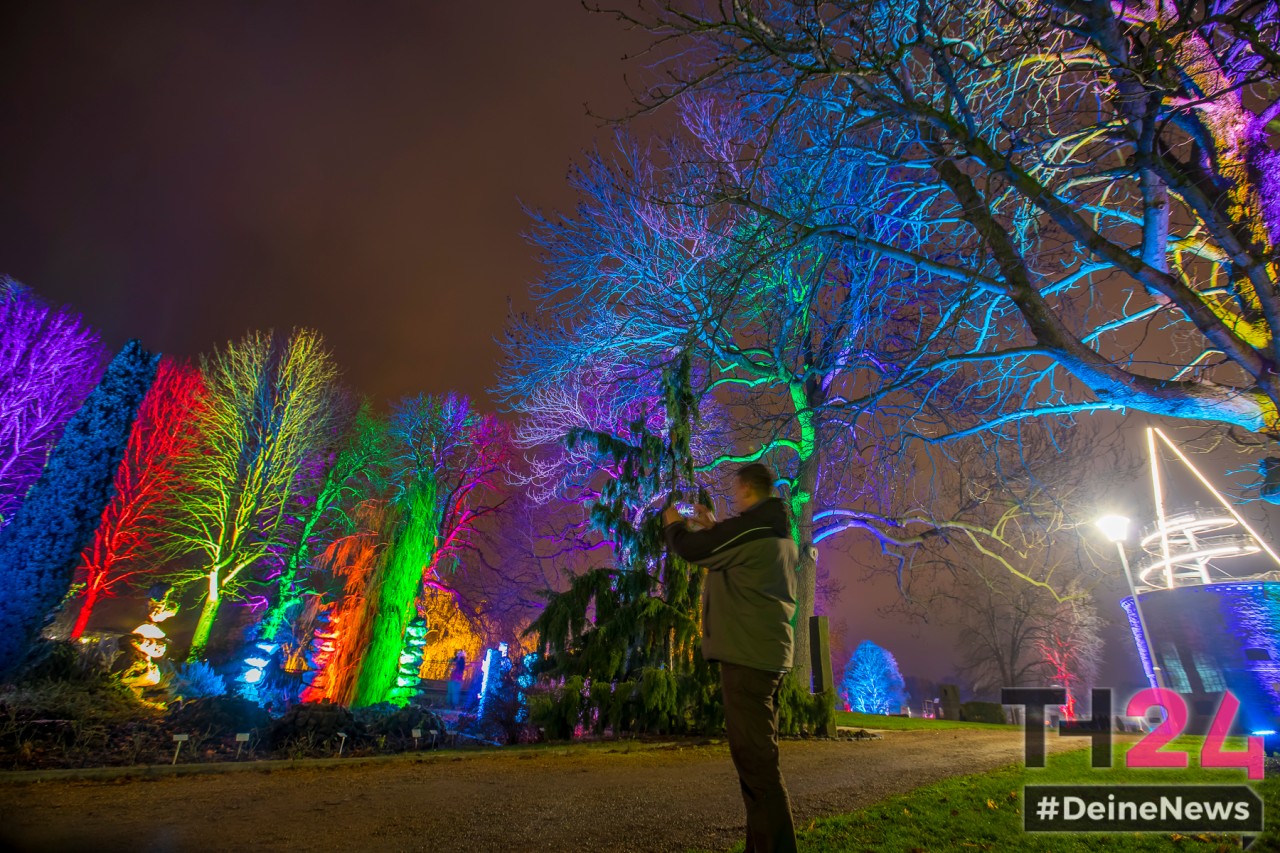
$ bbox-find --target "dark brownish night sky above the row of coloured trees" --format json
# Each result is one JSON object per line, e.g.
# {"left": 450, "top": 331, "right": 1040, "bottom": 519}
{"left": 0, "top": 0, "right": 1162, "bottom": 691}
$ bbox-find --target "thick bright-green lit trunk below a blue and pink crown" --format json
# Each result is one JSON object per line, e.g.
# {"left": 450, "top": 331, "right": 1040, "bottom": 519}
{"left": 351, "top": 483, "right": 439, "bottom": 707}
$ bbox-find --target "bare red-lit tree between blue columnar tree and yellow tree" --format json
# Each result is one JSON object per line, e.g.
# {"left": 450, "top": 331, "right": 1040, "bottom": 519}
{"left": 70, "top": 359, "right": 204, "bottom": 639}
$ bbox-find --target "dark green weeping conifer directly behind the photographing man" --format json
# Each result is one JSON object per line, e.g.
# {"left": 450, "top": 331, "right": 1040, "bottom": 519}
{"left": 526, "top": 356, "right": 723, "bottom": 738}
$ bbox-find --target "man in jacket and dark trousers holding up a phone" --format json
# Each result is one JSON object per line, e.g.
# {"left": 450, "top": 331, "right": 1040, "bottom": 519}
{"left": 663, "top": 464, "right": 800, "bottom": 853}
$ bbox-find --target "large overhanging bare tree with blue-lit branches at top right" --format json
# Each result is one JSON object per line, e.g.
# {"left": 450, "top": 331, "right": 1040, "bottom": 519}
{"left": 619, "top": 0, "right": 1280, "bottom": 441}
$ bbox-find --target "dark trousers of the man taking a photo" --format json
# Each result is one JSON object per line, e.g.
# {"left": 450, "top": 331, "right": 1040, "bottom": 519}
{"left": 721, "top": 662, "right": 796, "bottom": 853}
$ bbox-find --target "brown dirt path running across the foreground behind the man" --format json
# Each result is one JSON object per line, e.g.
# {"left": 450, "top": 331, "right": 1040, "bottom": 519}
{"left": 0, "top": 730, "right": 1080, "bottom": 853}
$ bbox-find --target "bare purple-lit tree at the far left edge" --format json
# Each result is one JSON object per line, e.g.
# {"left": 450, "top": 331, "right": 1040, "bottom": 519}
{"left": 0, "top": 277, "right": 102, "bottom": 528}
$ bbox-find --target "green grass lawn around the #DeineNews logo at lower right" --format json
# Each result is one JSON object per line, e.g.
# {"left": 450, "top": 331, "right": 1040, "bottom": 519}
{"left": 735, "top": 721, "right": 1280, "bottom": 853}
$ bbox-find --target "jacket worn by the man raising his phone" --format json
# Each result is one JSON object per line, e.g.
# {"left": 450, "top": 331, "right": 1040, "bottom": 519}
{"left": 666, "top": 498, "right": 800, "bottom": 672}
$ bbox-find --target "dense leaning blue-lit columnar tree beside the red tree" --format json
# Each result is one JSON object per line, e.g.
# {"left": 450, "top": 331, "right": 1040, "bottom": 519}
{"left": 0, "top": 341, "right": 159, "bottom": 678}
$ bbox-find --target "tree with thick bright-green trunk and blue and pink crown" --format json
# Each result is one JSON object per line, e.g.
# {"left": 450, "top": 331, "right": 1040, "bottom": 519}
{"left": 352, "top": 394, "right": 507, "bottom": 706}
